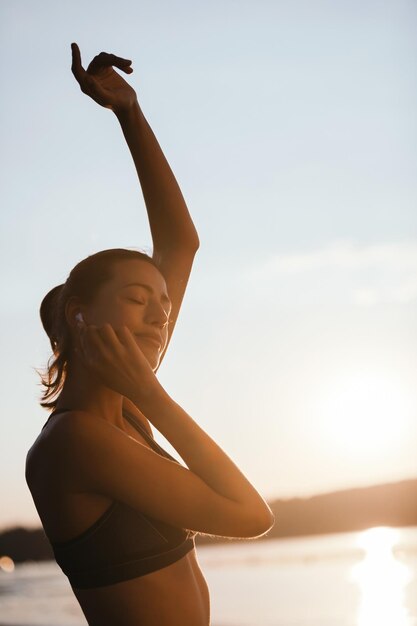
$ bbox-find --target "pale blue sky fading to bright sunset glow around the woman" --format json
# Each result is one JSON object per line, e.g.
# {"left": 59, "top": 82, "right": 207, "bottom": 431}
{"left": 0, "top": 0, "right": 417, "bottom": 529}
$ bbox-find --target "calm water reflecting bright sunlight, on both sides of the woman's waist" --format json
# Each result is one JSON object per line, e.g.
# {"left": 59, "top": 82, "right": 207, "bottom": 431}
{"left": 0, "top": 527, "right": 417, "bottom": 626}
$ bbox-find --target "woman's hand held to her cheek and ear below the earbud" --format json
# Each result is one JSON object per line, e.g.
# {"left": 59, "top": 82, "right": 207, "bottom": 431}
{"left": 76, "top": 322, "right": 163, "bottom": 404}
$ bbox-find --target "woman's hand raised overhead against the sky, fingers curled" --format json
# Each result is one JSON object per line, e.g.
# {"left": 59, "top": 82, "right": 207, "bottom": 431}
{"left": 71, "top": 43, "right": 137, "bottom": 114}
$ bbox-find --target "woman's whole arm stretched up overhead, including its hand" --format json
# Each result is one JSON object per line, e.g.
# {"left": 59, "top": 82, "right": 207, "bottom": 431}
{"left": 71, "top": 43, "right": 199, "bottom": 363}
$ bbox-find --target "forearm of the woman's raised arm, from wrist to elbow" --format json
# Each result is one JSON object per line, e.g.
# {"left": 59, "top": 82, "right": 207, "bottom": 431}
{"left": 117, "top": 103, "right": 199, "bottom": 250}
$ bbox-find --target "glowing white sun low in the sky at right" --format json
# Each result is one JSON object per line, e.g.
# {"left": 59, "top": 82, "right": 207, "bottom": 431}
{"left": 319, "top": 373, "right": 413, "bottom": 454}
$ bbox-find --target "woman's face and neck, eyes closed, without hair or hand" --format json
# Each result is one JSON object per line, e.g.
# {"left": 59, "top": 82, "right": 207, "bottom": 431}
{"left": 57, "top": 260, "right": 172, "bottom": 427}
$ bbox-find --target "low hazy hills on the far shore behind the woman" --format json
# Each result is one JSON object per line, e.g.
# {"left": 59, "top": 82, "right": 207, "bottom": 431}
{"left": 0, "top": 479, "right": 417, "bottom": 563}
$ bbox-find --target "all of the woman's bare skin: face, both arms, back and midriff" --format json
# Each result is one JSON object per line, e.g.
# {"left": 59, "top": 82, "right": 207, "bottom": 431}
{"left": 26, "top": 44, "right": 273, "bottom": 626}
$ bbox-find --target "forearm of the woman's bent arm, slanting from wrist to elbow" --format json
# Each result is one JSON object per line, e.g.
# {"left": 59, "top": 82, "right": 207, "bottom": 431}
{"left": 131, "top": 389, "right": 274, "bottom": 528}
